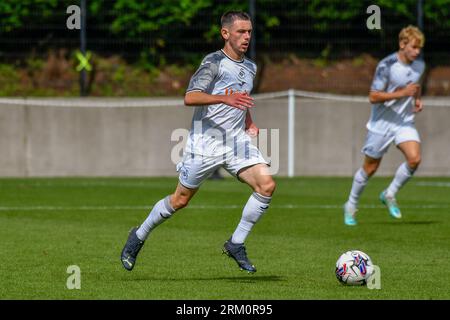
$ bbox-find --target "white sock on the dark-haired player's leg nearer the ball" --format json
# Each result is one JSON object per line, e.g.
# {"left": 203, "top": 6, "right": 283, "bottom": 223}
{"left": 231, "top": 192, "right": 272, "bottom": 244}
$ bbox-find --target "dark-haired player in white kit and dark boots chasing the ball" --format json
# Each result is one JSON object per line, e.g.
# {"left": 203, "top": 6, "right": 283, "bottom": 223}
{"left": 121, "top": 11, "right": 275, "bottom": 273}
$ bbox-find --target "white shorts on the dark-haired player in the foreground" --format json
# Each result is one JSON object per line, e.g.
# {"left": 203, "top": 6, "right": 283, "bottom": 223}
{"left": 177, "top": 143, "right": 269, "bottom": 189}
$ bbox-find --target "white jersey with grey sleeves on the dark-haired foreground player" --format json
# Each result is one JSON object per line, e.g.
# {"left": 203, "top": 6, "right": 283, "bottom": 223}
{"left": 186, "top": 50, "right": 256, "bottom": 157}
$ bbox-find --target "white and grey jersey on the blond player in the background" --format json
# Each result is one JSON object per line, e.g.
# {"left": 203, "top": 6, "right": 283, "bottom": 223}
{"left": 367, "top": 53, "right": 425, "bottom": 134}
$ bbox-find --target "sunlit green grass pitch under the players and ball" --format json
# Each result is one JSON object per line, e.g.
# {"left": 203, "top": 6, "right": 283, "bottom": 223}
{"left": 0, "top": 177, "right": 450, "bottom": 300}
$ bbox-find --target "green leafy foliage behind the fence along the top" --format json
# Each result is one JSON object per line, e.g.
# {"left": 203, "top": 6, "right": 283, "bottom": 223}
{"left": 0, "top": 0, "right": 450, "bottom": 63}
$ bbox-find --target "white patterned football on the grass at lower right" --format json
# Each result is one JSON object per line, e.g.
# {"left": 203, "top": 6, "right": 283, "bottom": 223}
{"left": 335, "top": 250, "right": 373, "bottom": 286}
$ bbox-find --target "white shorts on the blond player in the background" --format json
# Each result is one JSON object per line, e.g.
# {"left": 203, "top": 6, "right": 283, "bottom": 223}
{"left": 361, "top": 125, "right": 420, "bottom": 159}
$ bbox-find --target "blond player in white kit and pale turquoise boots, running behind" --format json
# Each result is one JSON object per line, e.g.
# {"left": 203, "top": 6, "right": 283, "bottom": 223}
{"left": 344, "top": 26, "right": 425, "bottom": 226}
